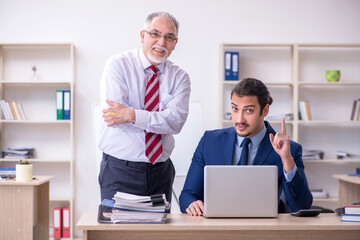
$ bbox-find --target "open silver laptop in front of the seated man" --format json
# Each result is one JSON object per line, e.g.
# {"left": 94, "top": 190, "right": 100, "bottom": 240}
{"left": 204, "top": 165, "right": 278, "bottom": 217}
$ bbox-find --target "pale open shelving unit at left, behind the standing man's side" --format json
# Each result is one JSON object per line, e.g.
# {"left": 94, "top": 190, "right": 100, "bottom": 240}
{"left": 0, "top": 43, "right": 75, "bottom": 237}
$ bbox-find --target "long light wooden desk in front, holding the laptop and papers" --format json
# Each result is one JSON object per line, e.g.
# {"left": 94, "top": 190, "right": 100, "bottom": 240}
{"left": 76, "top": 212, "right": 360, "bottom": 240}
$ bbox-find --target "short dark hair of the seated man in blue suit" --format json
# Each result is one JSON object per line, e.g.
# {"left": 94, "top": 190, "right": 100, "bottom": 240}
{"left": 231, "top": 78, "right": 273, "bottom": 115}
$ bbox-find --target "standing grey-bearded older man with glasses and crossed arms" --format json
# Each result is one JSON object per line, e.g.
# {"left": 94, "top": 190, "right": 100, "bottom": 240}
{"left": 98, "top": 12, "right": 190, "bottom": 204}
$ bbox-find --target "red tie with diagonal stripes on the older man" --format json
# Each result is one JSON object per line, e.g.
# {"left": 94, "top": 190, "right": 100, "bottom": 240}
{"left": 144, "top": 65, "right": 162, "bottom": 164}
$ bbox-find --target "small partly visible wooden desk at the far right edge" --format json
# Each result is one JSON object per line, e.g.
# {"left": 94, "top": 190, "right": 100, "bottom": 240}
{"left": 333, "top": 175, "right": 360, "bottom": 207}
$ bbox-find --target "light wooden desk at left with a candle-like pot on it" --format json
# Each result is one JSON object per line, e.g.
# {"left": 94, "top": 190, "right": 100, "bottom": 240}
{"left": 0, "top": 176, "right": 53, "bottom": 240}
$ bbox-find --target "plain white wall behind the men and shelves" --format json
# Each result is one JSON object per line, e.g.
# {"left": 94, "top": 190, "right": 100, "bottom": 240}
{"left": 0, "top": 0, "right": 360, "bottom": 234}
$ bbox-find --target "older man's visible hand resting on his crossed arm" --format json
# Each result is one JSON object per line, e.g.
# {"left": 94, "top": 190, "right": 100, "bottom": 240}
{"left": 103, "top": 100, "right": 136, "bottom": 127}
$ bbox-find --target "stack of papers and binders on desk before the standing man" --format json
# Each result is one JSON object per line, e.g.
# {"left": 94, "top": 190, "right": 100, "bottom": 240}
{"left": 98, "top": 192, "right": 170, "bottom": 223}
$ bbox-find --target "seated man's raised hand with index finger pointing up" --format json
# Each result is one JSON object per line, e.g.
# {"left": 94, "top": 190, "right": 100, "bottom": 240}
{"left": 269, "top": 118, "right": 295, "bottom": 172}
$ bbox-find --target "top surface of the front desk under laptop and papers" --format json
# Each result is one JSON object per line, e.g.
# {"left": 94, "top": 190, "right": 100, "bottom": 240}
{"left": 76, "top": 212, "right": 360, "bottom": 231}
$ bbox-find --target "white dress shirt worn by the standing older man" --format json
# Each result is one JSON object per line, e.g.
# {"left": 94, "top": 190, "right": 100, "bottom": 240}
{"left": 98, "top": 48, "right": 190, "bottom": 162}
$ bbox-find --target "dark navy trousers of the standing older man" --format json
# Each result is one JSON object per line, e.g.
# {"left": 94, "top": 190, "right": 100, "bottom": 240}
{"left": 99, "top": 153, "right": 175, "bottom": 202}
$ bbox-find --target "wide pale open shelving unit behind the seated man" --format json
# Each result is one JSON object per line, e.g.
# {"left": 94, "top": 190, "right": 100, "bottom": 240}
{"left": 219, "top": 44, "right": 360, "bottom": 209}
